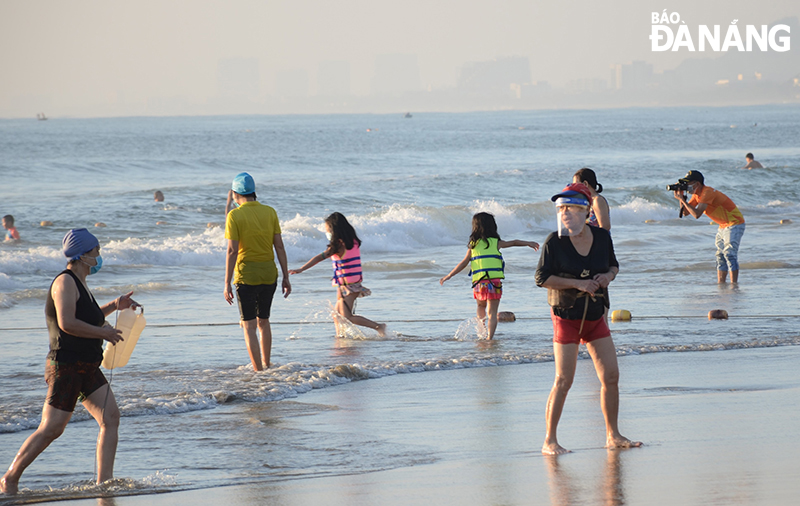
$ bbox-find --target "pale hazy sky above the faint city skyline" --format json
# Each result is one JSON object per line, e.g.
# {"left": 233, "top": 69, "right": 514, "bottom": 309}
{"left": 0, "top": 0, "right": 800, "bottom": 117}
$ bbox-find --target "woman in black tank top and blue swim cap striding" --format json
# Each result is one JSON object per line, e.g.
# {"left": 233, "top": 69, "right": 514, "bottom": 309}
{"left": 0, "top": 228, "right": 138, "bottom": 495}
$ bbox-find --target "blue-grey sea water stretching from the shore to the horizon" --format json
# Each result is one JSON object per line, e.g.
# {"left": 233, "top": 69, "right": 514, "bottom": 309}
{"left": 0, "top": 106, "right": 800, "bottom": 498}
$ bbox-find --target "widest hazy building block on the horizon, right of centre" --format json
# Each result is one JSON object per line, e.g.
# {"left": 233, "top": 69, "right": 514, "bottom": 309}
{"left": 457, "top": 57, "right": 531, "bottom": 98}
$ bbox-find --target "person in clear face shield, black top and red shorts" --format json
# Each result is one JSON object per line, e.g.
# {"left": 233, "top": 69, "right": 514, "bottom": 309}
{"left": 536, "top": 183, "right": 641, "bottom": 455}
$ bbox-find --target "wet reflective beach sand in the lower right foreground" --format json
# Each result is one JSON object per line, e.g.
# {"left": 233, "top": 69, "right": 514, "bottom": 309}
{"left": 10, "top": 346, "right": 800, "bottom": 506}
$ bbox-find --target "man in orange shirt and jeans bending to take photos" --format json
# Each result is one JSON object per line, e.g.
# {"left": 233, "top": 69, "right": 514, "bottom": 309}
{"left": 674, "top": 170, "right": 744, "bottom": 283}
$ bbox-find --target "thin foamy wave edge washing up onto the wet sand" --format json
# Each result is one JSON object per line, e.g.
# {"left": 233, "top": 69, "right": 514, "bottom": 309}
{"left": 0, "top": 336, "right": 800, "bottom": 433}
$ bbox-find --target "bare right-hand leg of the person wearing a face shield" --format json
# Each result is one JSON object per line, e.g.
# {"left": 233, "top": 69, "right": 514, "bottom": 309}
{"left": 586, "top": 336, "right": 642, "bottom": 448}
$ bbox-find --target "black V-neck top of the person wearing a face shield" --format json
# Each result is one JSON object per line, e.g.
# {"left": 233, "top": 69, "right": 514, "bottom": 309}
{"left": 536, "top": 227, "right": 619, "bottom": 320}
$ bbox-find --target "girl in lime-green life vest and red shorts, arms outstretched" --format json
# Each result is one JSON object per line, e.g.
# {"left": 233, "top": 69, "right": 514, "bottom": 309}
{"left": 439, "top": 212, "right": 539, "bottom": 340}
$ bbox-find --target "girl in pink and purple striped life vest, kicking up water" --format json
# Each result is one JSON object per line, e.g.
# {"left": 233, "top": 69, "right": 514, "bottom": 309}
{"left": 289, "top": 213, "right": 386, "bottom": 337}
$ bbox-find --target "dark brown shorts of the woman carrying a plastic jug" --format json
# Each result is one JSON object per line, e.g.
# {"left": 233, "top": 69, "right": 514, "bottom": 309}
{"left": 44, "top": 360, "right": 108, "bottom": 413}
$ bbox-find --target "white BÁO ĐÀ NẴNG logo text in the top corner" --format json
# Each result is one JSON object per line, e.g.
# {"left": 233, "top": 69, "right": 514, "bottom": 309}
{"left": 650, "top": 9, "right": 791, "bottom": 52}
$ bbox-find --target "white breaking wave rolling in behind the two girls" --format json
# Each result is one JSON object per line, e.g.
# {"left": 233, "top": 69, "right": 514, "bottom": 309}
{"left": 0, "top": 197, "right": 764, "bottom": 276}
